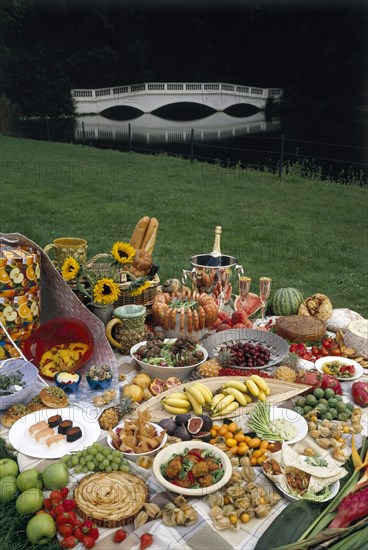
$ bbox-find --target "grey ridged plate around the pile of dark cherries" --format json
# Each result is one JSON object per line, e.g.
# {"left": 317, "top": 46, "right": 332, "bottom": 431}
{"left": 201, "top": 328, "right": 289, "bottom": 371}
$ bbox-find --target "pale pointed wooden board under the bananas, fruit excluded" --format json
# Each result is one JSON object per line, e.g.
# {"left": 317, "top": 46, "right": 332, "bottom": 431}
{"left": 133, "top": 376, "right": 310, "bottom": 422}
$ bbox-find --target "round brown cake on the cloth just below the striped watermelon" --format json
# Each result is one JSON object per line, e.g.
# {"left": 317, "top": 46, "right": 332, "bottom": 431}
{"left": 275, "top": 315, "right": 326, "bottom": 342}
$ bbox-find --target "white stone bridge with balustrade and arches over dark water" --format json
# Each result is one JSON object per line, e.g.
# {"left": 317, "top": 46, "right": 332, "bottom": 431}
{"left": 72, "top": 82, "right": 283, "bottom": 114}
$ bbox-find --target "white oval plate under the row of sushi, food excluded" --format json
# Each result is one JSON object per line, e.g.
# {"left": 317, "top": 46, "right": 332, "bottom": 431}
{"left": 9, "top": 407, "right": 100, "bottom": 458}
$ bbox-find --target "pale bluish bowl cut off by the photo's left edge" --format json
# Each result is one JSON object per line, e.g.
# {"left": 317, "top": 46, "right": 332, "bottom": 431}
{"left": 0, "top": 358, "right": 38, "bottom": 411}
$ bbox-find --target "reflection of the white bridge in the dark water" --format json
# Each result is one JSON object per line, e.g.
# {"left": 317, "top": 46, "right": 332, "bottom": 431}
{"left": 75, "top": 111, "right": 281, "bottom": 144}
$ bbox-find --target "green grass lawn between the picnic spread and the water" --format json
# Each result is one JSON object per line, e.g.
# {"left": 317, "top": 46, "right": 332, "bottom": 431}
{"left": 0, "top": 137, "right": 368, "bottom": 316}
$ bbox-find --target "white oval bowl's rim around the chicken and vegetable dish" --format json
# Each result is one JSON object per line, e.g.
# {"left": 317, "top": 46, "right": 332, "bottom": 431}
{"left": 153, "top": 441, "right": 233, "bottom": 497}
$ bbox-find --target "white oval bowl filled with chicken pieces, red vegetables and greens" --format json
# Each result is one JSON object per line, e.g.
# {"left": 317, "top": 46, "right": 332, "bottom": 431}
{"left": 153, "top": 440, "right": 232, "bottom": 497}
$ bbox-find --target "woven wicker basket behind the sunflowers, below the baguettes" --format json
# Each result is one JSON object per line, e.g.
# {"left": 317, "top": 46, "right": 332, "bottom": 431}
{"left": 86, "top": 254, "right": 160, "bottom": 315}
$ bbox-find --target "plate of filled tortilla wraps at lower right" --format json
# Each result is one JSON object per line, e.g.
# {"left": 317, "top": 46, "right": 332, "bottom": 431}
{"left": 262, "top": 443, "right": 347, "bottom": 502}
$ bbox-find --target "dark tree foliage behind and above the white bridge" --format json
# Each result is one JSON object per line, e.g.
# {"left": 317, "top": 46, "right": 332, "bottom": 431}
{"left": 0, "top": 0, "right": 367, "bottom": 115}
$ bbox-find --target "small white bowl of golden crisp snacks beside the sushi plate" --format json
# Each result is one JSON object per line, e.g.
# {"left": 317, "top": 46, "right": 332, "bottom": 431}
{"left": 107, "top": 411, "right": 167, "bottom": 462}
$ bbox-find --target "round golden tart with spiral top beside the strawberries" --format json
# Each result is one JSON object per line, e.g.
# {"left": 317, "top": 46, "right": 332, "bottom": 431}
{"left": 74, "top": 471, "right": 148, "bottom": 528}
